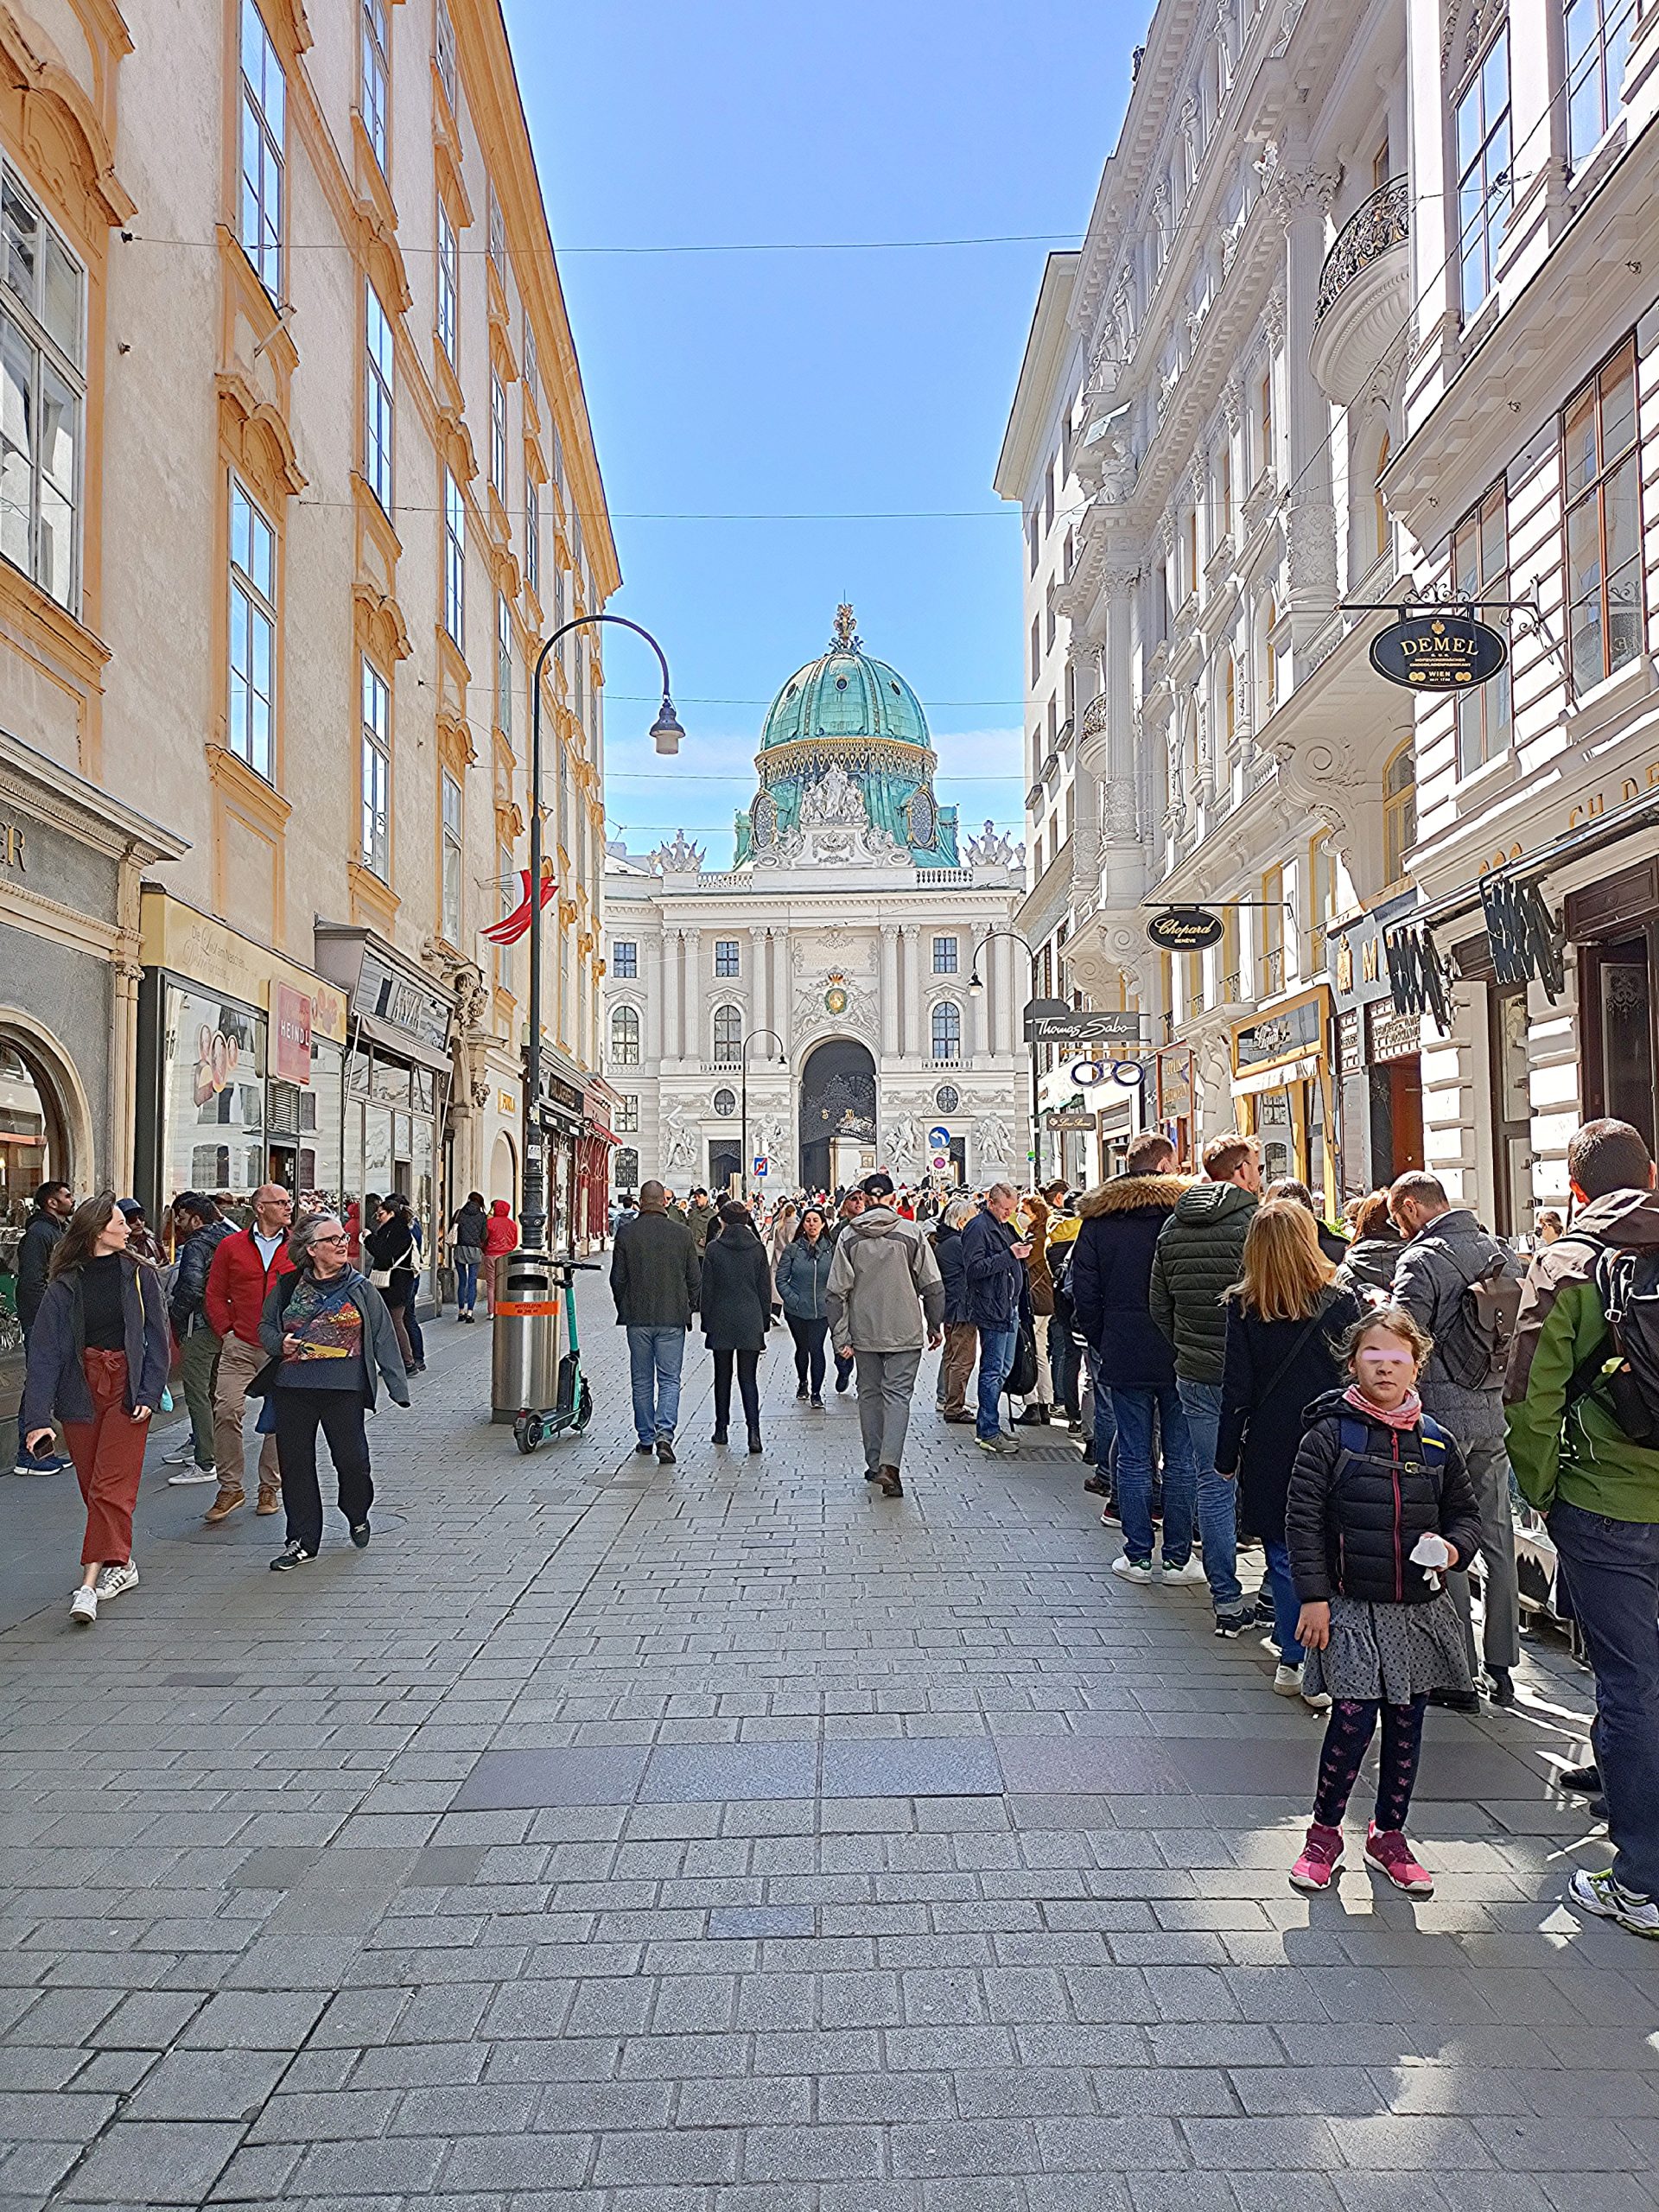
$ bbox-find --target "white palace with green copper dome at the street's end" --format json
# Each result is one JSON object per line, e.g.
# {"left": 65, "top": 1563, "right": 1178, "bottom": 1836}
{"left": 604, "top": 608, "right": 1031, "bottom": 1194}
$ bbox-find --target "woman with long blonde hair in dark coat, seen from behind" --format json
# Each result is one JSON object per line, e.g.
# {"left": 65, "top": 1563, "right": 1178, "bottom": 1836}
{"left": 1214, "top": 1199, "right": 1360, "bottom": 1706}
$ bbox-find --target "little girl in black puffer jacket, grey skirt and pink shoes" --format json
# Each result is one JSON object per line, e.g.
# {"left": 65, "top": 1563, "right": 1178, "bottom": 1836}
{"left": 1285, "top": 1305, "right": 1480, "bottom": 1896}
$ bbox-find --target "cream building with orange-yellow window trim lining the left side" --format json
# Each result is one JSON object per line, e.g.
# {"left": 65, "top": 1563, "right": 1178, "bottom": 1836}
{"left": 0, "top": 0, "right": 620, "bottom": 1327}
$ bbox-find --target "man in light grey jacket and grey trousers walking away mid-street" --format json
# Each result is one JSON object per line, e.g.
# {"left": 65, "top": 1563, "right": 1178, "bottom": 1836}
{"left": 825, "top": 1174, "right": 944, "bottom": 1497}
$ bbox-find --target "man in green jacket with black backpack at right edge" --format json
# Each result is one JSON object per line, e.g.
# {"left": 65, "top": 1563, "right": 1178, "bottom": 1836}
{"left": 1504, "top": 1122, "right": 1659, "bottom": 1938}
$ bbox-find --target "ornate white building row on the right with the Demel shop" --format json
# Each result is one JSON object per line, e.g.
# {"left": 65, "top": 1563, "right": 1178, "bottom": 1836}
{"left": 998, "top": 0, "right": 1659, "bottom": 1232}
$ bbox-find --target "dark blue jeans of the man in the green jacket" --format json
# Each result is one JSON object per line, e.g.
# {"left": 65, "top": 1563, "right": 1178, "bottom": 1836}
{"left": 1548, "top": 1502, "right": 1659, "bottom": 1897}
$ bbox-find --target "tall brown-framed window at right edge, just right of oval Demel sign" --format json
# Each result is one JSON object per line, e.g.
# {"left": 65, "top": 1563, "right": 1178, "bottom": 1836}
{"left": 1561, "top": 339, "right": 1642, "bottom": 692}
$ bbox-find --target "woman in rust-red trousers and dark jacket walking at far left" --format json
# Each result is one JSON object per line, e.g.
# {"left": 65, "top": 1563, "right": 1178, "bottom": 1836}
{"left": 22, "top": 1190, "right": 173, "bottom": 1628}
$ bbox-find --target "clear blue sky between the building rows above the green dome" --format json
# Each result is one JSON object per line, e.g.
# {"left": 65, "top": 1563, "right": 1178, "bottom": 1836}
{"left": 506, "top": 0, "right": 1146, "bottom": 865}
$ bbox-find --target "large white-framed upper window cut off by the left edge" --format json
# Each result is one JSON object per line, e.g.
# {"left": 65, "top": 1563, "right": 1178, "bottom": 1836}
{"left": 0, "top": 166, "right": 86, "bottom": 613}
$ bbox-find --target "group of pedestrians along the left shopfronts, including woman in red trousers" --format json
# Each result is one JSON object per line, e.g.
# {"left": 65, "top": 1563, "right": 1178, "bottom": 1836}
{"left": 13, "top": 1181, "right": 518, "bottom": 1626}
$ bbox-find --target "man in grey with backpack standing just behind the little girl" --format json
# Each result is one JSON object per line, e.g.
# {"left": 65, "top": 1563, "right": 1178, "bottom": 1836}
{"left": 1389, "top": 1170, "right": 1522, "bottom": 1712}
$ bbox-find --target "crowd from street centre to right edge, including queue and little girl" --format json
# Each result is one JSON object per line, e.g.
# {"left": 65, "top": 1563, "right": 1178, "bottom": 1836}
{"left": 613, "top": 1119, "right": 1659, "bottom": 1936}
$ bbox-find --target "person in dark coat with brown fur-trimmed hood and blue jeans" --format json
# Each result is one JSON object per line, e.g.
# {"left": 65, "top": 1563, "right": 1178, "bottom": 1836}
{"left": 1068, "top": 1130, "right": 1204, "bottom": 1581}
